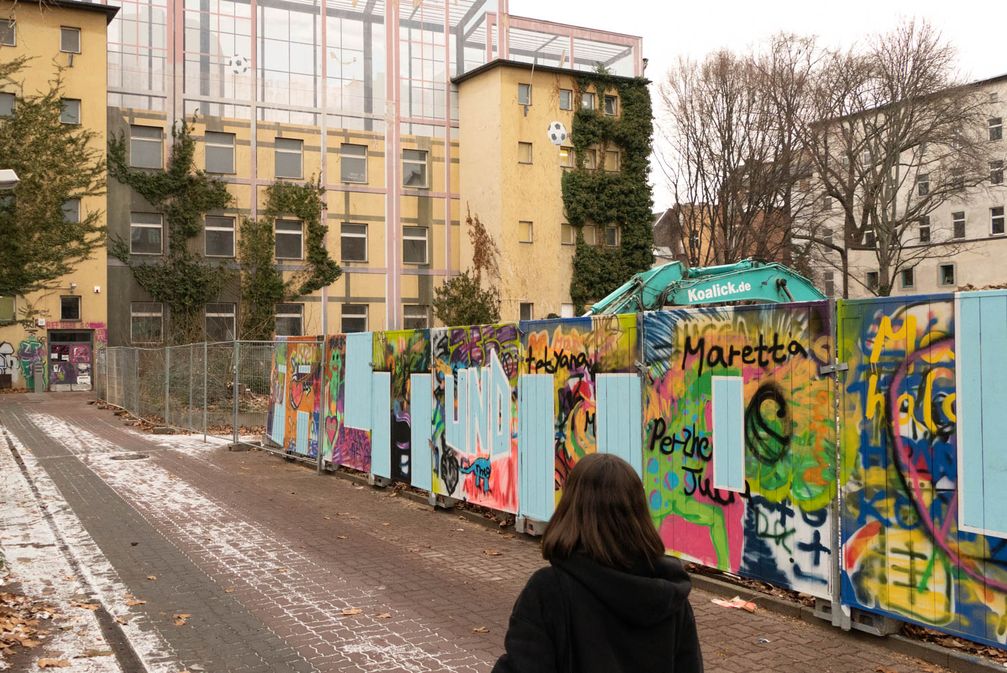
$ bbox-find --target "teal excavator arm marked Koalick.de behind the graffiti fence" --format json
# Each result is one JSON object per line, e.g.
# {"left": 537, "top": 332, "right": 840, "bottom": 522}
{"left": 587, "top": 259, "right": 825, "bottom": 315}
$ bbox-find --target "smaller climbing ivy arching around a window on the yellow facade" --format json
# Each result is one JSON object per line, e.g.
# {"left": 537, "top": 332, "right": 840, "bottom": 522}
{"left": 238, "top": 181, "right": 342, "bottom": 340}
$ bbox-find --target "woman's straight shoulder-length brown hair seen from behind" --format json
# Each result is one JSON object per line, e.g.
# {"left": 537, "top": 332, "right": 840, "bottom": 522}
{"left": 542, "top": 453, "right": 665, "bottom": 570}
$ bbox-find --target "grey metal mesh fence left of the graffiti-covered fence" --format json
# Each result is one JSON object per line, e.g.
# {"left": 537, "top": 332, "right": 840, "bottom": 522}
{"left": 96, "top": 342, "right": 283, "bottom": 445}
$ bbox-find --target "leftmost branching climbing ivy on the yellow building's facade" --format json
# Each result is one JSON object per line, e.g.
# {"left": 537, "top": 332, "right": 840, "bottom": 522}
{"left": 109, "top": 120, "right": 234, "bottom": 344}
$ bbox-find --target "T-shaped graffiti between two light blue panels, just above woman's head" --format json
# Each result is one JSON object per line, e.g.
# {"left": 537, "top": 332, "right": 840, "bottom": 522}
{"left": 521, "top": 315, "right": 636, "bottom": 503}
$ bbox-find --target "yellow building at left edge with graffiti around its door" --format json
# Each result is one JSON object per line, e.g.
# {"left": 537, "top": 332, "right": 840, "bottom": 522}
{"left": 0, "top": 0, "right": 117, "bottom": 391}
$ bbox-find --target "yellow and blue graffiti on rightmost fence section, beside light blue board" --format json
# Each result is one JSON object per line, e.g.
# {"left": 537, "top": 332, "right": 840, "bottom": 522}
{"left": 839, "top": 295, "right": 1007, "bottom": 645}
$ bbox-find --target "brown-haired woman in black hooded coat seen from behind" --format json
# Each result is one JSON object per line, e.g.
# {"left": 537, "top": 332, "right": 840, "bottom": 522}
{"left": 493, "top": 453, "right": 703, "bottom": 673}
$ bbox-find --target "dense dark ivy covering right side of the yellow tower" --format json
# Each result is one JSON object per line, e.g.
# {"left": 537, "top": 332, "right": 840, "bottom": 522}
{"left": 563, "top": 71, "right": 654, "bottom": 312}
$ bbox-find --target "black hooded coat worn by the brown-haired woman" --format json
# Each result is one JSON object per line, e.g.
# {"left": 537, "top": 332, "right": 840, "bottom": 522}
{"left": 492, "top": 555, "right": 703, "bottom": 673}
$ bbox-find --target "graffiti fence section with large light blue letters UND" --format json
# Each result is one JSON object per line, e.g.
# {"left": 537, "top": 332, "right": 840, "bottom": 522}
{"left": 428, "top": 323, "right": 521, "bottom": 513}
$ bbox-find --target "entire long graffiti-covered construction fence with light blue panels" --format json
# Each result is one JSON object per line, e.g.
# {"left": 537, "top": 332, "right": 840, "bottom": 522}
{"left": 259, "top": 292, "right": 1007, "bottom": 647}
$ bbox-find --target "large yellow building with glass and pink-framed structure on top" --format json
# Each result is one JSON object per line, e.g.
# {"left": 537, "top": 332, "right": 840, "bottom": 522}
{"left": 108, "top": 0, "right": 642, "bottom": 345}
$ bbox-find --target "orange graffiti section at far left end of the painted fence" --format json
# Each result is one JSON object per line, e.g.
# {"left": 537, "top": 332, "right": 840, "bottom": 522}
{"left": 266, "top": 337, "right": 321, "bottom": 456}
